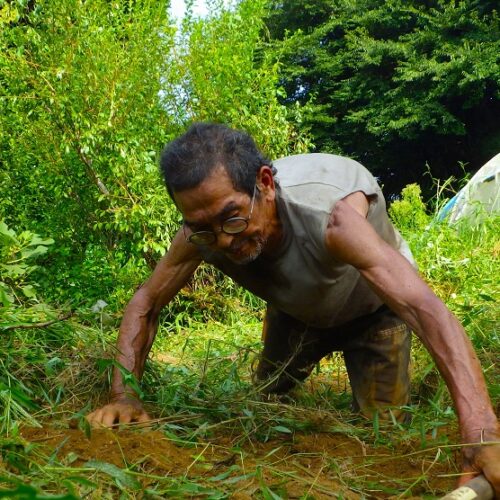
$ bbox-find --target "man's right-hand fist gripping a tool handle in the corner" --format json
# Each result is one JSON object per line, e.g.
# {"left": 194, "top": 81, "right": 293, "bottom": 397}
{"left": 458, "top": 431, "right": 500, "bottom": 499}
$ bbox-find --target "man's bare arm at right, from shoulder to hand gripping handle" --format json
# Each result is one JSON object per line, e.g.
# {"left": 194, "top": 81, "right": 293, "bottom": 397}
{"left": 326, "top": 192, "right": 500, "bottom": 498}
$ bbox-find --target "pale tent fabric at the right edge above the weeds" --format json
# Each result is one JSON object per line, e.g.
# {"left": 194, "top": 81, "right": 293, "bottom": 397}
{"left": 439, "top": 153, "right": 500, "bottom": 222}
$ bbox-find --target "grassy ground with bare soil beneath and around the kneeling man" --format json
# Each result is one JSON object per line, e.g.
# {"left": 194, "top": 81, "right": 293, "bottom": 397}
{"left": 0, "top": 187, "right": 500, "bottom": 499}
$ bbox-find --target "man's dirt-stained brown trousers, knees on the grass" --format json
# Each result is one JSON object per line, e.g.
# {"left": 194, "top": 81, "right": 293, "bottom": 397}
{"left": 254, "top": 306, "right": 411, "bottom": 420}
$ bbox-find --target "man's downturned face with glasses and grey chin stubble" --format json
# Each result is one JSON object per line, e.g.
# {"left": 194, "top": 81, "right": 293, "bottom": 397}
{"left": 174, "top": 167, "right": 267, "bottom": 264}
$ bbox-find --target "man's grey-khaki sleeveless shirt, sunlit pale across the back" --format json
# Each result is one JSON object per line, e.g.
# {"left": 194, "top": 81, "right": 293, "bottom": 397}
{"left": 201, "top": 153, "right": 415, "bottom": 328}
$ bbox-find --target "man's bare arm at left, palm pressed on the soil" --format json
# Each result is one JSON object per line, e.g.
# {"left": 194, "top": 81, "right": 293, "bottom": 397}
{"left": 87, "top": 231, "right": 201, "bottom": 426}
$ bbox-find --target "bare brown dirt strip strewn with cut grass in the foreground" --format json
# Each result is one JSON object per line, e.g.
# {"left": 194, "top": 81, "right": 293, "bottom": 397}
{"left": 18, "top": 423, "right": 454, "bottom": 499}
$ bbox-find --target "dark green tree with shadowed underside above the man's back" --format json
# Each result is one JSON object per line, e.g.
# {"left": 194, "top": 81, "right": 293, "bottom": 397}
{"left": 268, "top": 0, "right": 500, "bottom": 192}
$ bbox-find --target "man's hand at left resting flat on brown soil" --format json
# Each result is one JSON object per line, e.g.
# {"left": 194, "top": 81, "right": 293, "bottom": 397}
{"left": 86, "top": 397, "right": 151, "bottom": 427}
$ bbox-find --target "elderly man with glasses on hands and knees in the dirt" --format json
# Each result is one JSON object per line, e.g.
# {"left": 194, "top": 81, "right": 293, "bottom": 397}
{"left": 88, "top": 123, "right": 500, "bottom": 495}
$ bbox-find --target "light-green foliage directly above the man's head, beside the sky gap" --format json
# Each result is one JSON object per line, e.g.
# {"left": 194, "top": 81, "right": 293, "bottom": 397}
{"left": 173, "top": 0, "right": 310, "bottom": 157}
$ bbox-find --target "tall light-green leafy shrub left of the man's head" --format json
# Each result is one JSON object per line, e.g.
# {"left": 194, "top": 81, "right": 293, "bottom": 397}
{"left": 0, "top": 0, "right": 177, "bottom": 253}
